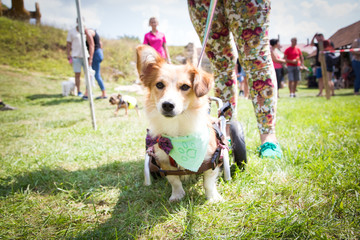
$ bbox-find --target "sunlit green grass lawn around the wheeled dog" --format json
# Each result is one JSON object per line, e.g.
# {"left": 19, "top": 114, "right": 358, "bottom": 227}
{"left": 0, "top": 66, "right": 360, "bottom": 239}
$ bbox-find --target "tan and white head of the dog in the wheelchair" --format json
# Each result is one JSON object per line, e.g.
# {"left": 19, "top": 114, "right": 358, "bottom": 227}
{"left": 136, "top": 45, "right": 213, "bottom": 117}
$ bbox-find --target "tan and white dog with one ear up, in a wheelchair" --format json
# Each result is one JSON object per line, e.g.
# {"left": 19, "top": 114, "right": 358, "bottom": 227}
{"left": 136, "top": 45, "right": 222, "bottom": 202}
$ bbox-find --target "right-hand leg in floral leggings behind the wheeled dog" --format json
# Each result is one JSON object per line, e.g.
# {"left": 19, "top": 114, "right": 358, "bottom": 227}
{"left": 225, "top": 0, "right": 281, "bottom": 154}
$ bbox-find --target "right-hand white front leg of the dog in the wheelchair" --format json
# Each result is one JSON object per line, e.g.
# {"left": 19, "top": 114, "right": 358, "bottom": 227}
{"left": 204, "top": 167, "right": 223, "bottom": 202}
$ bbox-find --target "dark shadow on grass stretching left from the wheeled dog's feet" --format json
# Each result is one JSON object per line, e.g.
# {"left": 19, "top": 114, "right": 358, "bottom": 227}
{"left": 0, "top": 159, "right": 205, "bottom": 239}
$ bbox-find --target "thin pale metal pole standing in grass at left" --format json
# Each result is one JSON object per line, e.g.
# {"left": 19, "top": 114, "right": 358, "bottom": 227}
{"left": 75, "top": 0, "right": 97, "bottom": 131}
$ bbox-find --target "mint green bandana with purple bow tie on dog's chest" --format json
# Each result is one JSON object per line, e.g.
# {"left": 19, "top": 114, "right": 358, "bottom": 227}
{"left": 146, "top": 126, "right": 210, "bottom": 172}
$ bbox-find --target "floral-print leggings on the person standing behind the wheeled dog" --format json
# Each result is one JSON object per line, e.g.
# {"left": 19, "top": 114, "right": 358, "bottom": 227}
{"left": 188, "top": 0, "right": 277, "bottom": 134}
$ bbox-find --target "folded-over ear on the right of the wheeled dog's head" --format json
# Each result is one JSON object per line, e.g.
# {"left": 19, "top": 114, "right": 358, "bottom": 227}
{"left": 188, "top": 65, "right": 214, "bottom": 97}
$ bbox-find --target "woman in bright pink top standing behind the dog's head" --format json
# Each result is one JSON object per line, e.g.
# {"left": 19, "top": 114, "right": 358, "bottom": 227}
{"left": 144, "top": 17, "right": 171, "bottom": 63}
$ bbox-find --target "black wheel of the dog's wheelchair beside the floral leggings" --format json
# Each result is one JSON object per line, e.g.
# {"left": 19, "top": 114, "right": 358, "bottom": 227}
{"left": 229, "top": 121, "right": 247, "bottom": 169}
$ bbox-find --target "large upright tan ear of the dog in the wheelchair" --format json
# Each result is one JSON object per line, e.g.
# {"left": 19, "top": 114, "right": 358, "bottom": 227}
{"left": 136, "top": 45, "right": 165, "bottom": 85}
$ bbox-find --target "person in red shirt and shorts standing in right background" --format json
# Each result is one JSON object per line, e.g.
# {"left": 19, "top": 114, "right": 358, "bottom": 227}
{"left": 284, "top": 38, "right": 304, "bottom": 98}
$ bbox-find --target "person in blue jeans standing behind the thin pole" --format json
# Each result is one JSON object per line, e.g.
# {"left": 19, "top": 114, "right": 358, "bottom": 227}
{"left": 83, "top": 28, "right": 107, "bottom": 100}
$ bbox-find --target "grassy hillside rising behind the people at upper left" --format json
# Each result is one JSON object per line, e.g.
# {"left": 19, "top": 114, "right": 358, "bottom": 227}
{"left": 0, "top": 17, "right": 184, "bottom": 83}
